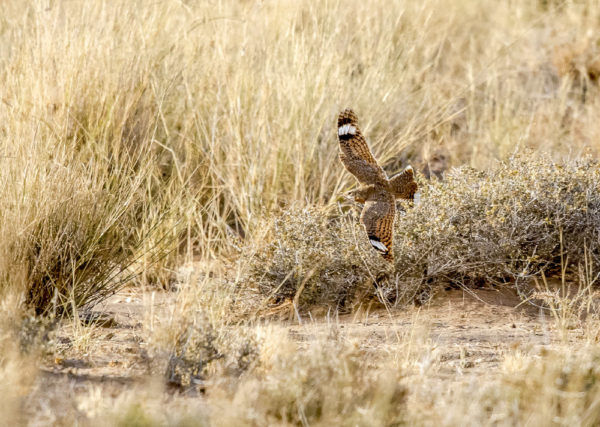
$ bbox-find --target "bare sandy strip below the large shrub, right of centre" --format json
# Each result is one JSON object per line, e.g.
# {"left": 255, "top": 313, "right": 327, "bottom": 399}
{"left": 289, "top": 290, "right": 578, "bottom": 378}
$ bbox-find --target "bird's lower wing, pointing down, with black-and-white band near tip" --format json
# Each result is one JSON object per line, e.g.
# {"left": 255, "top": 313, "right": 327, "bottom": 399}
{"left": 360, "top": 191, "right": 396, "bottom": 262}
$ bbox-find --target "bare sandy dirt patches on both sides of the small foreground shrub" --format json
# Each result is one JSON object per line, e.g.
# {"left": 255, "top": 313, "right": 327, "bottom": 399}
{"left": 27, "top": 284, "right": 583, "bottom": 424}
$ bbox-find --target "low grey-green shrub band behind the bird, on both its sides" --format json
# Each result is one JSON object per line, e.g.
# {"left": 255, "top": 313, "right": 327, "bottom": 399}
{"left": 245, "top": 158, "right": 600, "bottom": 306}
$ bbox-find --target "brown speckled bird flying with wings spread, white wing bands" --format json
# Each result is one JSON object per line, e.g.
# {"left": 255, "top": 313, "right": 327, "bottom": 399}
{"left": 338, "top": 109, "right": 419, "bottom": 262}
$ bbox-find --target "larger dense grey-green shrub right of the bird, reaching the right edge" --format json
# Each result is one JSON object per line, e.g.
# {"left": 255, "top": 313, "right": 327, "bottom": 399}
{"left": 395, "top": 157, "right": 600, "bottom": 298}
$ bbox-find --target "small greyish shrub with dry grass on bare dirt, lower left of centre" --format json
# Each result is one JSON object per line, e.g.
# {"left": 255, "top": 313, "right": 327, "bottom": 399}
{"left": 149, "top": 277, "right": 262, "bottom": 389}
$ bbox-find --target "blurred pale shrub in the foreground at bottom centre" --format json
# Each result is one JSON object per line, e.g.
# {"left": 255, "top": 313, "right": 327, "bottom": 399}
{"left": 209, "top": 340, "right": 406, "bottom": 426}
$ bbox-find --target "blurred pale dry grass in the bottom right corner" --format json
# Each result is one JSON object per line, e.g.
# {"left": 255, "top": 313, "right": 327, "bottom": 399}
{"left": 410, "top": 345, "right": 599, "bottom": 426}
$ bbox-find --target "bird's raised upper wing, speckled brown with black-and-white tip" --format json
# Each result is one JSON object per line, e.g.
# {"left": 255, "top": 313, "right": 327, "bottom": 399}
{"left": 338, "top": 110, "right": 387, "bottom": 184}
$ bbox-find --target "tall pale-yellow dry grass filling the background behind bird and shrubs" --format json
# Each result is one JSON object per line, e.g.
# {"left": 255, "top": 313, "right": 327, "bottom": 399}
{"left": 0, "top": 0, "right": 600, "bottom": 312}
